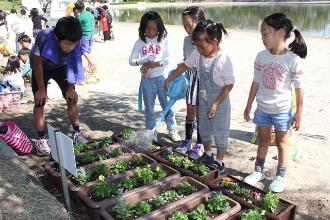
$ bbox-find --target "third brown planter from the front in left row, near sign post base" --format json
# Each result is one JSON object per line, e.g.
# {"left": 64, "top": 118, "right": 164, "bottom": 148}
{"left": 78, "top": 164, "right": 181, "bottom": 219}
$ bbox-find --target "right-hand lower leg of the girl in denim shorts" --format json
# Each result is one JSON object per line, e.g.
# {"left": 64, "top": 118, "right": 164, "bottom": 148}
{"left": 276, "top": 131, "right": 289, "bottom": 177}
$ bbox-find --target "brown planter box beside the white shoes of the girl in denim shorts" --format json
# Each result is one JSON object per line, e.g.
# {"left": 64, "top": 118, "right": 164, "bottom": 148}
{"left": 209, "top": 175, "right": 297, "bottom": 220}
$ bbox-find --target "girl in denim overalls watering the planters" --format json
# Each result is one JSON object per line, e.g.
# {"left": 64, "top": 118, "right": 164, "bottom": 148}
{"left": 165, "top": 20, "right": 235, "bottom": 172}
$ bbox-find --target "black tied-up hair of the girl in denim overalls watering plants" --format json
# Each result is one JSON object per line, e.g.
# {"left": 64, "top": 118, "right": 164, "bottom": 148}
{"left": 192, "top": 19, "right": 227, "bottom": 43}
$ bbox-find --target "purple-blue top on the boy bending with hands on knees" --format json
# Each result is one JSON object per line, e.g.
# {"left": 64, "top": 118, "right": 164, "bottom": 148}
{"left": 30, "top": 28, "right": 85, "bottom": 84}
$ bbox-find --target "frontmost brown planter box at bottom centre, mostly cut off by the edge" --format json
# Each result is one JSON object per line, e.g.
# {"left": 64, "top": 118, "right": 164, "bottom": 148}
{"left": 157, "top": 192, "right": 241, "bottom": 220}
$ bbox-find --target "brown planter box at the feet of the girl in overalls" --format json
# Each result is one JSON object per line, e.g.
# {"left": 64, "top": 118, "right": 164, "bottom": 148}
{"left": 151, "top": 149, "right": 220, "bottom": 184}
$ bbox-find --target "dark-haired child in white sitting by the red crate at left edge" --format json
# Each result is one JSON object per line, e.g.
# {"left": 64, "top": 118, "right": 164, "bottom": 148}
{"left": 2, "top": 56, "right": 25, "bottom": 94}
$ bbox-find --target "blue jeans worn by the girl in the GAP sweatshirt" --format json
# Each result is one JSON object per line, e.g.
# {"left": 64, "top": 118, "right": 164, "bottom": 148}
{"left": 141, "top": 76, "right": 176, "bottom": 130}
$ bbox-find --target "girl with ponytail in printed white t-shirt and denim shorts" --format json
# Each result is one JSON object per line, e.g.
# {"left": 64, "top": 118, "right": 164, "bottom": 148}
{"left": 244, "top": 13, "right": 307, "bottom": 192}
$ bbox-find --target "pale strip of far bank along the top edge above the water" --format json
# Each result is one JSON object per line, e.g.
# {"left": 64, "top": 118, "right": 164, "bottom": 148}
{"left": 109, "top": 1, "right": 330, "bottom": 9}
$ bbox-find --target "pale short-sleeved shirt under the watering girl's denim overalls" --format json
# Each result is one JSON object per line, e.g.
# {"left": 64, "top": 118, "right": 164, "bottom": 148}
{"left": 184, "top": 49, "right": 235, "bottom": 87}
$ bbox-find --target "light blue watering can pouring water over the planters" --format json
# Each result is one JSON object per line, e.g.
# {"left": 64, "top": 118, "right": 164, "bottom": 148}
{"left": 147, "top": 70, "right": 189, "bottom": 139}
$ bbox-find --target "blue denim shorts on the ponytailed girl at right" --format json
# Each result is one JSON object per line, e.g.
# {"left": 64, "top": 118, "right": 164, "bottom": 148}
{"left": 253, "top": 108, "right": 292, "bottom": 131}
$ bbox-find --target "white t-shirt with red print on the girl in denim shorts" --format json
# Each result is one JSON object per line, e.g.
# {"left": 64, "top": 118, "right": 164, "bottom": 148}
{"left": 253, "top": 50, "right": 303, "bottom": 114}
